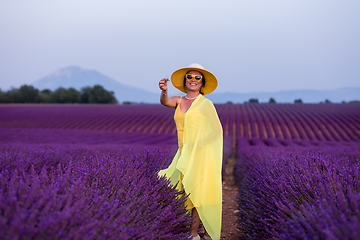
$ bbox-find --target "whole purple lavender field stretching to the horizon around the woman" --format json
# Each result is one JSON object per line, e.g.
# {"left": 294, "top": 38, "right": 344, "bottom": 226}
{"left": 0, "top": 104, "right": 360, "bottom": 239}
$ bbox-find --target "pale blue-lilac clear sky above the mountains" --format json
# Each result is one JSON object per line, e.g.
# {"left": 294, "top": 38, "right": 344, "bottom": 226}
{"left": 0, "top": 0, "right": 360, "bottom": 95}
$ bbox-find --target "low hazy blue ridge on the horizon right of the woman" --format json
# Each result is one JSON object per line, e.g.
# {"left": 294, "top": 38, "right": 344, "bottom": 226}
{"left": 208, "top": 87, "right": 360, "bottom": 103}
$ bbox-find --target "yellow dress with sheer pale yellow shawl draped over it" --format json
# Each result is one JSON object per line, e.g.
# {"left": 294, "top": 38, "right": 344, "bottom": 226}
{"left": 159, "top": 95, "right": 223, "bottom": 240}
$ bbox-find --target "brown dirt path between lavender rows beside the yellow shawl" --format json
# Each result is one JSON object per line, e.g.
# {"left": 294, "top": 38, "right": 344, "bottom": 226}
{"left": 220, "top": 157, "right": 239, "bottom": 240}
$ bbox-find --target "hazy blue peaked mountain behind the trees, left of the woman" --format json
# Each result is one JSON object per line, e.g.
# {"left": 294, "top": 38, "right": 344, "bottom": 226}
{"left": 31, "top": 66, "right": 159, "bottom": 103}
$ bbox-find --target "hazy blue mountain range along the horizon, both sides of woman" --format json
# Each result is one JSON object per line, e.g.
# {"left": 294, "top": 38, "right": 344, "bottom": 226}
{"left": 32, "top": 66, "right": 360, "bottom": 103}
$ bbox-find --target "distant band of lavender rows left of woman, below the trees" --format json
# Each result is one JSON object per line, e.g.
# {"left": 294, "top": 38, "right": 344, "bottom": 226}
{"left": 0, "top": 104, "right": 176, "bottom": 134}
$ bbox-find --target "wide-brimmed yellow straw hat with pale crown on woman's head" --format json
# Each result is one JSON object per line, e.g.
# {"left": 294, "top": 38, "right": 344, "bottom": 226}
{"left": 171, "top": 63, "right": 217, "bottom": 95}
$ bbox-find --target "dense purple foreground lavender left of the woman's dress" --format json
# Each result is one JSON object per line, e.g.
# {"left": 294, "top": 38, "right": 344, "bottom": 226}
{"left": 0, "top": 144, "right": 190, "bottom": 239}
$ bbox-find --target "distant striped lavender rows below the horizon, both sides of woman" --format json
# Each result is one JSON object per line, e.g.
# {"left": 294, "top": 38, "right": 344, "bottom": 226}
{"left": 0, "top": 103, "right": 360, "bottom": 142}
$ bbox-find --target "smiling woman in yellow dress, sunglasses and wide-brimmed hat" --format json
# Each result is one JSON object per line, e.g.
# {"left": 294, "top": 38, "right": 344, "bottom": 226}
{"left": 159, "top": 64, "right": 223, "bottom": 240}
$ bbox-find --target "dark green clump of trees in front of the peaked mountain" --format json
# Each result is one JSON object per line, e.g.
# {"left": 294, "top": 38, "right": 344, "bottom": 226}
{"left": 0, "top": 85, "right": 117, "bottom": 103}
